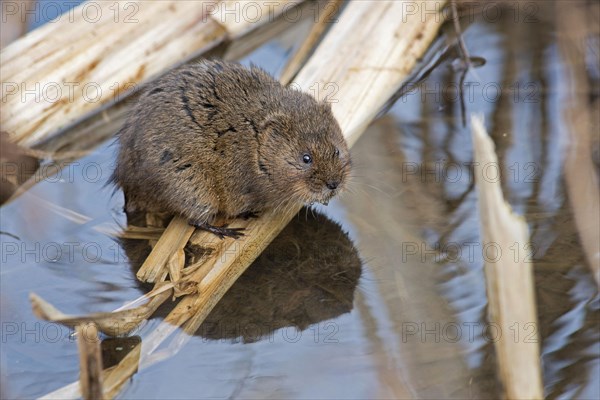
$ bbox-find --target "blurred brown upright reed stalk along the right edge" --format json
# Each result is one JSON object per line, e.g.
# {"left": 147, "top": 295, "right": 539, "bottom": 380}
{"left": 556, "top": 2, "right": 600, "bottom": 286}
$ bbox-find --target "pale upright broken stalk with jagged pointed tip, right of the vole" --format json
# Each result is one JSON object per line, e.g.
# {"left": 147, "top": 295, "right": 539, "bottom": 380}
{"left": 471, "top": 116, "right": 544, "bottom": 399}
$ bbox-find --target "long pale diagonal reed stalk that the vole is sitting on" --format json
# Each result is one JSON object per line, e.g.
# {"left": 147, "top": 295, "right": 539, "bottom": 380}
{"left": 38, "top": 0, "right": 445, "bottom": 398}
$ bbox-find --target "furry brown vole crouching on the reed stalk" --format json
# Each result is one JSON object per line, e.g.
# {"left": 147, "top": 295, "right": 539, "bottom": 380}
{"left": 113, "top": 61, "right": 350, "bottom": 237}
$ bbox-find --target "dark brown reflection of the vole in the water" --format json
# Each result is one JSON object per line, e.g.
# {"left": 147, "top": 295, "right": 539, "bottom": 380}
{"left": 123, "top": 209, "right": 362, "bottom": 342}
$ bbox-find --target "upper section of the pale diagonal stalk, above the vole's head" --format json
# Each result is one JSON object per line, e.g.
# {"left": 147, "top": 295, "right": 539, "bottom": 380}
{"left": 294, "top": 1, "right": 446, "bottom": 145}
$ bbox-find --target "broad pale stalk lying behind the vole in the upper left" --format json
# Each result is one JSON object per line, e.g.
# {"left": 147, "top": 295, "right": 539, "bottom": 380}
{"left": 0, "top": 0, "right": 303, "bottom": 146}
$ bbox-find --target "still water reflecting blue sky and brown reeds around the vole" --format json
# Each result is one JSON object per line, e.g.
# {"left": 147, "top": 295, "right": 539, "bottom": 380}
{"left": 0, "top": 2, "right": 600, "bottom": 399}
